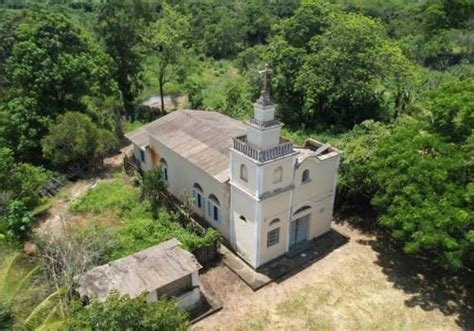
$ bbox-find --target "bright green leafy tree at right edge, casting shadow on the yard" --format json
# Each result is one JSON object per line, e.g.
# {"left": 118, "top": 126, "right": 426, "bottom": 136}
{"left": 370, "top": 119, "right": 474, "bottom": 269}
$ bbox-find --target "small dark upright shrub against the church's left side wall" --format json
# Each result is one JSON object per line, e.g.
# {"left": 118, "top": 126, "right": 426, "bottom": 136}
{"left": 141, "top": 167, "right": 167, "bottom": 218}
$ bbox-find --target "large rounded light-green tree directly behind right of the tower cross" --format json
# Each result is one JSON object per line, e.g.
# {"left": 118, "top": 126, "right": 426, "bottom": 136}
{"left": 268, "top": 1, "right": 411, "bottom": 128}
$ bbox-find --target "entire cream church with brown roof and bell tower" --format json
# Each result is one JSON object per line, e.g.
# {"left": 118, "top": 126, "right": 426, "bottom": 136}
{"left": 126, "top": 67, "right": 341, "bottom": 268}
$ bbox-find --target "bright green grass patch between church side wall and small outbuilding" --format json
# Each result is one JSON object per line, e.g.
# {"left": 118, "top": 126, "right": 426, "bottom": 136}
{"left": 71, "top": 174, "right": 219, "bottom": 260}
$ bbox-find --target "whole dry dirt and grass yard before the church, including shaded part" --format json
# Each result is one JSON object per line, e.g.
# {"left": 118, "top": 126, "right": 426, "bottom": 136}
{"left": 193, "top": 225, "right": 474, "bottom": 330}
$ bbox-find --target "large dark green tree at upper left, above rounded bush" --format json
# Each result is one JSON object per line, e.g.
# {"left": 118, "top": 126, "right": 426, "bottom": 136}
{"left": 0, "top": 9, "right": 114, "bottom": 162}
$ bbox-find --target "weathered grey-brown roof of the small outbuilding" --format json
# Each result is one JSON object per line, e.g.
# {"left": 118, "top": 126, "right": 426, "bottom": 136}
{"left": 76, "top": 238, "right": 202, "bottom": 300}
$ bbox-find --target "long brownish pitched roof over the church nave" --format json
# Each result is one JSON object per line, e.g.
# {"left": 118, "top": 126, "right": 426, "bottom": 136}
{"left": 125, "top": 110, "right": 246, "bottom": 182}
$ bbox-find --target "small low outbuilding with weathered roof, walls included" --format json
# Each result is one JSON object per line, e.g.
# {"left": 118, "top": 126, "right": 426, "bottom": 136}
{"left": 76, "top": 238, "right": 202, "bottom": 309}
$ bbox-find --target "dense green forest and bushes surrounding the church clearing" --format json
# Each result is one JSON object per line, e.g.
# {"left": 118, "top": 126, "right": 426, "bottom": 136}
{"left": 0, "top": 0, "right": 474, "bottom": 330}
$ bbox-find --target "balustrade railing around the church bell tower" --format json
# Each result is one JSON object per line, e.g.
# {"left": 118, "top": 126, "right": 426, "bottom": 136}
{"left": 233, "top": 135, "right": 293, "bottom": 162}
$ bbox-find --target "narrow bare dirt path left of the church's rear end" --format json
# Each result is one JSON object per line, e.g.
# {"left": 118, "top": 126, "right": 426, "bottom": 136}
{"left": 35, "top": 145, "right": 132, "bottom": 239}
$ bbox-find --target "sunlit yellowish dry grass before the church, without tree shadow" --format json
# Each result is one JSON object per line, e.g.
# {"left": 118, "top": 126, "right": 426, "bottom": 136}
{"left": 236, "top": 243, "right": 459, "bottom": 330}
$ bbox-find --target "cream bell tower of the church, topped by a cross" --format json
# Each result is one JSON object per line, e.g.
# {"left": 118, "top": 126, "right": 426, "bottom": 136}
{"left": 230, "top": 65, "right": 297, "bottom": 268}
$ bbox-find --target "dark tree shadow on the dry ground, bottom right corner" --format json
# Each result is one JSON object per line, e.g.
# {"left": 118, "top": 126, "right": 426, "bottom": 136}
{"left": 357, "top": 234, "right": 474, "bottom": 330}
